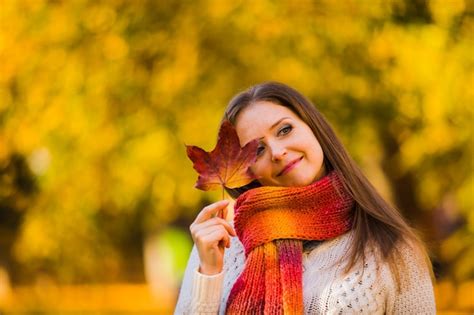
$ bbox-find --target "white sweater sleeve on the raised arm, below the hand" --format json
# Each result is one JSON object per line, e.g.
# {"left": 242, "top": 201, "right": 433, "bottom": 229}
{"left": 174, "top": 246, "right": 224, "bottom": 315}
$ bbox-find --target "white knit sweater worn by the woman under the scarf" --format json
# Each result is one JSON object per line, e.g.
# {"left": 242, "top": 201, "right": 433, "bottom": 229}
{"left": 175, "top": 228, "right": 436, "bottom": 314}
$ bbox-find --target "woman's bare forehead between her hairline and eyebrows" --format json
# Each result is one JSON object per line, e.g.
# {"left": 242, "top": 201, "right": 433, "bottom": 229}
{"left": 235, "top": 101, "right": 298, "bottom": 146}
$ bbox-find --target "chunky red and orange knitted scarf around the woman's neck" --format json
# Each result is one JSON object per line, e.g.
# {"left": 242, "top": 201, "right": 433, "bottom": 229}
{"left": 226, "top": 171, "right": 354, "bottom": 314}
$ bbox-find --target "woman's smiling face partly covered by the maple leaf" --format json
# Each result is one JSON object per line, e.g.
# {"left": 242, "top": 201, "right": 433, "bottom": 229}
{"left": 236, "top": 101, "right": 325, "bottom": 186}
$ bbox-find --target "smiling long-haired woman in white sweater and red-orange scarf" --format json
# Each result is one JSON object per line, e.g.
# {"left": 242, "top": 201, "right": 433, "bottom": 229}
{"left": 175, "top": 82, "right": 435, "bottom": 314}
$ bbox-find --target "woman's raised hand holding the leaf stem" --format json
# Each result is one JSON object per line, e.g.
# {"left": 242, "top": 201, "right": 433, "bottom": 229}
{"left": 189, "top": 200, "right": 236, "bottom": 275}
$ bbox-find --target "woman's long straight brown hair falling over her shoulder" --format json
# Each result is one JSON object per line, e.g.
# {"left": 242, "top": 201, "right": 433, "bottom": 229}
{"left": 223, "top": 82, "right": 433, "bottom": 289}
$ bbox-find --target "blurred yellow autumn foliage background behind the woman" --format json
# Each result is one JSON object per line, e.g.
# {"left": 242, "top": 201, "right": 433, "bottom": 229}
{"left": 0, "top": 0, "right": 474, "bottom": 314}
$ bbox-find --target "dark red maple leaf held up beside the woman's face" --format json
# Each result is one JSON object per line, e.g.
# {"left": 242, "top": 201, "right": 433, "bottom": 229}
{"left": 186, "top": 121, "right": 258, "bottom": 190}
